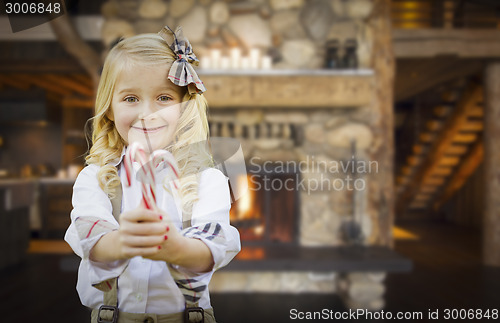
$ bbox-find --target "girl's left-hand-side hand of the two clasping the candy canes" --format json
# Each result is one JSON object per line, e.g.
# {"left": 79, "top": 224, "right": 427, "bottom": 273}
{"left": 118, "top": 206, "right": 167, "bottom": 259}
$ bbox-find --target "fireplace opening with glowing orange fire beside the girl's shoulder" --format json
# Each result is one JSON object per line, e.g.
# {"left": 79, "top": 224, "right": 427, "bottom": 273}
{"left": 230, "top": 165, "right": 299, "bottom": 245}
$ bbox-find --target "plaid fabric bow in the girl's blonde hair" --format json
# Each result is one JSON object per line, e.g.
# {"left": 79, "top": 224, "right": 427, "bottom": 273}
{"left": 158, "top": 26, "right": 207, "bottom": 94}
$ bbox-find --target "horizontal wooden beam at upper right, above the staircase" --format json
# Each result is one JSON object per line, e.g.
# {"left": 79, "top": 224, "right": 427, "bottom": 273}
{"left": 392, "top": 29, "right": 500, "bottom": 58}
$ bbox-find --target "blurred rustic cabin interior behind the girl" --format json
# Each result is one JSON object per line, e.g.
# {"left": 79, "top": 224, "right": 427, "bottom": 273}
{"left": 0, "top": 0, "right": 500, "bottom": 323}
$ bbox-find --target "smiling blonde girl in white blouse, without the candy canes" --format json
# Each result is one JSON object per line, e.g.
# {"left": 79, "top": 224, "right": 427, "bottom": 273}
{"left": 65, "top": 27, "right": 240, "bottom": 323}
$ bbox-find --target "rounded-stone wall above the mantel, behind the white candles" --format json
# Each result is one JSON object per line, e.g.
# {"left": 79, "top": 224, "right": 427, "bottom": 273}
{"left": 102, "top": 0, "right": 372, "bottom": 69}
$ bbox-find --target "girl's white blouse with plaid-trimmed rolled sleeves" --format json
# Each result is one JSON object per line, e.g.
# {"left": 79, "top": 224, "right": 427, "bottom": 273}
{"left": 64, "top": 156, "right": 241, "bottom": 314}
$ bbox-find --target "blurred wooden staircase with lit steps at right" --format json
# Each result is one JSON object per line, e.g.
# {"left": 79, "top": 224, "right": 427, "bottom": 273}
{"left": 396, "top": 84, "right": 483, "bottom": 214}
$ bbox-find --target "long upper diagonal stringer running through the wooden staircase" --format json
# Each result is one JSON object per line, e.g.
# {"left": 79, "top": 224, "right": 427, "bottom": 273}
{"left": 396, "top": 85, "right": 483, "bottom": 213}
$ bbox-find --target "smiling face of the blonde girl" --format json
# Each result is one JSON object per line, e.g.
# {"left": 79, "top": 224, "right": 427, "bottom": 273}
{"left": 110, "top": 63, "right": 184, "bottom": 152}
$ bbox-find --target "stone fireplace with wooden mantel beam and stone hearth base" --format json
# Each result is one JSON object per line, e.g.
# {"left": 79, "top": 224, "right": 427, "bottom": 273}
{"left": 202, "top": 69, "right": 396, "bottom": 309}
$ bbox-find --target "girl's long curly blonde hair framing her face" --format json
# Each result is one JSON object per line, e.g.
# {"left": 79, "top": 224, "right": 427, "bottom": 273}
{"left": 86, "top": 34, "right": 213, "bottom": 218}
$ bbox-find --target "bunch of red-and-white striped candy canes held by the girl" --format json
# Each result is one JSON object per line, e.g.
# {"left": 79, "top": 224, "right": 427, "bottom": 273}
{"left": 124, "top": 142, "right": 179, "bottom": 210}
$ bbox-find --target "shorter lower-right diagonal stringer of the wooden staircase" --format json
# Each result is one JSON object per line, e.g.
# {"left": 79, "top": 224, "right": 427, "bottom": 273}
{"left": 433, "top": 140, "right": 484, "bottom": 211}
